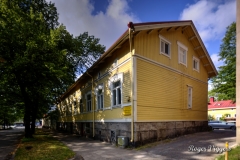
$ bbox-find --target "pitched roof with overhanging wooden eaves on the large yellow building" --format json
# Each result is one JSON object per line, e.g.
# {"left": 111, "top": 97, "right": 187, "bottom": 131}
{"left": 58, "top": 20, "right": 217, "bottom": 98}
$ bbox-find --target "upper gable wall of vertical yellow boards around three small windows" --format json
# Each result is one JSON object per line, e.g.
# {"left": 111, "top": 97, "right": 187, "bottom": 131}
{"left": 134, "top": 30, "right": 208, "bottom": 82}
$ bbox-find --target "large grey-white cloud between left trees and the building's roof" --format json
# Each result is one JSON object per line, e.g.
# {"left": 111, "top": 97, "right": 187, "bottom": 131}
{"left": 48, "top": 0, "right": 139, "bottom": 49}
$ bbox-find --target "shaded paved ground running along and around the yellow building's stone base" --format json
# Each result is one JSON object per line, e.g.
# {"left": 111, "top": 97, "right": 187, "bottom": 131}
{"left": 56, "top": 130, "right": 236, "bottom": 160}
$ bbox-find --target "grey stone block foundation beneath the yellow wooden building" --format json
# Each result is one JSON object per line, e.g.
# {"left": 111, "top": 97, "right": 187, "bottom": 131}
{"left": 56, "top": 121, "right": 208, "bottom": 146}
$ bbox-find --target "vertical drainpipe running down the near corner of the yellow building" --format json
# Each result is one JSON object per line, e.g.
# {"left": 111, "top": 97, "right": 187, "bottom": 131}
{"left": 128, "top": 22, "right": 134, "bottom": 143}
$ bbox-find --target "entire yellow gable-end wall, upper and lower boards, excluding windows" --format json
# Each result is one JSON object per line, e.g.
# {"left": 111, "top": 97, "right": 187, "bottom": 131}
{"left": 134, "top": 31, "right": 208, "bottom": 121}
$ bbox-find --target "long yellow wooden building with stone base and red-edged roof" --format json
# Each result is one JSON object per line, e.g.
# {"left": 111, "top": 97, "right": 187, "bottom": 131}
{"left": 58, "top": 21, "right": 217, "bottom": 144}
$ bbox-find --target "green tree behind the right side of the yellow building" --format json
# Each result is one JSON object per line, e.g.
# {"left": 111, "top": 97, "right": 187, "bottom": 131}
{"left": 212, "top": 22, "right": 236, "bottom": 102}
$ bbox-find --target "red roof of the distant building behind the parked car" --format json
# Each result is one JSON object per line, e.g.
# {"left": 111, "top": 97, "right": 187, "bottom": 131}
{"left": 208, "top": 100, "right": 236, "bottom": 110}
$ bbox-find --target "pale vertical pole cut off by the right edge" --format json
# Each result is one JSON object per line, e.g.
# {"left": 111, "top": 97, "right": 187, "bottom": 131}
{"left": 236, "top": 0, "right": 240, "bottom": 145}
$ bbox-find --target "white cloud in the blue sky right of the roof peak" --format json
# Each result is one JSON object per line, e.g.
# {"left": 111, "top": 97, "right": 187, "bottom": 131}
{"left": 180, "top": 0, "right": 236, "bottom": 42}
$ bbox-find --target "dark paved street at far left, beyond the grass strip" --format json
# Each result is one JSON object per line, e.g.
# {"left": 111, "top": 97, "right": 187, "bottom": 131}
{"left": 0, "top": 129, "right": 24, "bottom": 160}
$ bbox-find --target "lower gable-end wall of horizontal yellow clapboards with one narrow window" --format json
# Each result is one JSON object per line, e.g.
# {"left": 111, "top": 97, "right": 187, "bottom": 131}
{"left": 137, "top": 59, "right": 207, "bottom": 121}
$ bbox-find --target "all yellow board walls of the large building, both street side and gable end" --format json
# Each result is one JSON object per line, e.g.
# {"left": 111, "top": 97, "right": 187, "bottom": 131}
{"left": 58, "top": 30, "right": 212, "bottom": 122}
